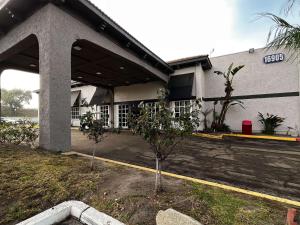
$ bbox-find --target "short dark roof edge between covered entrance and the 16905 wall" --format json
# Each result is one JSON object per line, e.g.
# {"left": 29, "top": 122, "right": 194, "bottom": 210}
{"left": 168, "top": 55, "right": 212, "bottom": 70}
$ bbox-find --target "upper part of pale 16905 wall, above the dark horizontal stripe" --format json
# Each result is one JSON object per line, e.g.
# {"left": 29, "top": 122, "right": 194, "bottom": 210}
{"left": 204, "top": 49, "right": 299, "bottom": 97}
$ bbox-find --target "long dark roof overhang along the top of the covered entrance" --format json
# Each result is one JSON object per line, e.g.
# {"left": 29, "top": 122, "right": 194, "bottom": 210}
{"left": 0, "top": 0, "right": 174, "bottom": 74}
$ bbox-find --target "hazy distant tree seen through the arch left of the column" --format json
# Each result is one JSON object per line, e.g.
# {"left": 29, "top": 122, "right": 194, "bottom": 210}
{"left": 1, "top": 89, "right": 32, "bottom": 115}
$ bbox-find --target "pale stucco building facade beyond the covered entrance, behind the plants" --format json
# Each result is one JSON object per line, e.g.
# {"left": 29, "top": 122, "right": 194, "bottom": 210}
{"left": 74, "top": 46, "right": 300, "bottom": 133}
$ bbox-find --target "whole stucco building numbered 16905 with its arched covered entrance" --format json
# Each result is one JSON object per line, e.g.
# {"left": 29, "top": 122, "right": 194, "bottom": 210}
{"left": 0, "top": 0, "right": 300, "bottom": 151}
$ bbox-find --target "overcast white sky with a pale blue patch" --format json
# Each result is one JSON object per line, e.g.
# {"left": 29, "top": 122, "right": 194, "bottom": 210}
{"left": 2, "top": 0, "right": 299, "bottom": 108}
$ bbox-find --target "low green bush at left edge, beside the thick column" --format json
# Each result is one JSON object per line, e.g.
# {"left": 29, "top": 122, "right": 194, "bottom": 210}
{"left": 0, "top": 121, "right": 39, "bottom": 147}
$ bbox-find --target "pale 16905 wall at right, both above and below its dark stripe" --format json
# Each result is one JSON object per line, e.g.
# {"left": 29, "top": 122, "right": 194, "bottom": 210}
{"left": 204, "top": 49, "right": 300, "bottom": 131}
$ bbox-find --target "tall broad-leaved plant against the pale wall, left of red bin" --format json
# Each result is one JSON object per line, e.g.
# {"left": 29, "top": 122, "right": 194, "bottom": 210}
{"left": 213, "top": 63, "right": 244, "bottom": 130}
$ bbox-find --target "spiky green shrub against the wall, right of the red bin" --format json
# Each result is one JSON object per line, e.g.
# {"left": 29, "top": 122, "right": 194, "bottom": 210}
{"left": 258, "top": 112, "right": 285, "bottom": 134}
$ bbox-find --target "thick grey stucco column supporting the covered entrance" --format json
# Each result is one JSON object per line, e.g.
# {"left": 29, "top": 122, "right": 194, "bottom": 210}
{"left": 39, "top": 35, "right": 72, "bottom": 152}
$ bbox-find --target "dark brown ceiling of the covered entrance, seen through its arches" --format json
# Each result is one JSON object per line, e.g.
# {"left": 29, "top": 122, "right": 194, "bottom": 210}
{"left": 0, "top": 35, "right": 164, "bottom": 88}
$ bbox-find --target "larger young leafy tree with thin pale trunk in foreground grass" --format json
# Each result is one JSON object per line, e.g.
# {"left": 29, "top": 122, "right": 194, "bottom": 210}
{"left": 129, "top": 89, "right": 201, "bottom": 193}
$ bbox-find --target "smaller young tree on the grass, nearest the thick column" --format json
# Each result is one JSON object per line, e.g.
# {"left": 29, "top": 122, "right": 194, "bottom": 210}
{"left": 80, "top": 112, "right": 107, "bottom": 171}
